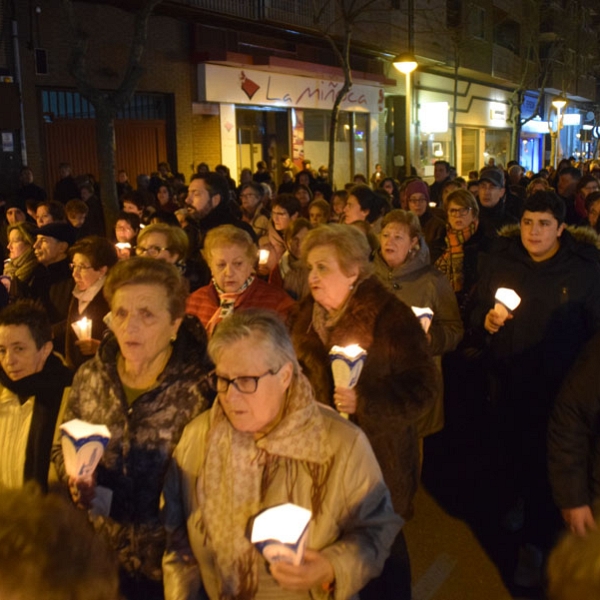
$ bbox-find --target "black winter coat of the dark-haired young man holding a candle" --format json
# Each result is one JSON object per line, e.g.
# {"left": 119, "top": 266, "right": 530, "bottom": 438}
{"left": 472, "top": 228, "right": 600, "bottom": 420}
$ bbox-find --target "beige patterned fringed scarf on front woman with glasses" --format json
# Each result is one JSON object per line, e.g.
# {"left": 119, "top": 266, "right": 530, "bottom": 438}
{"left": 196, "top": 374, "right": 335, "bottom": 600}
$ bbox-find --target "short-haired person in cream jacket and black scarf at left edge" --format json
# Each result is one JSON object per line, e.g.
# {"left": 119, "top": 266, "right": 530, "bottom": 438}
{"left": 0, "top": 300, "right": 73, "bottom": 490}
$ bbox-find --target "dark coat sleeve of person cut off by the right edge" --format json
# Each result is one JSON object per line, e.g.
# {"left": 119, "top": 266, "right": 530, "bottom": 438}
{"left": 548, "top": 333, "right": 600, "bottom": 508}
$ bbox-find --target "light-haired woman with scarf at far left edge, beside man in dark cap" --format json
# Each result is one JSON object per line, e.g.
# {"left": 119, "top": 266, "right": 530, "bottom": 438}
{"left": 3, "top": 223, "right": 38, "bottom": 300}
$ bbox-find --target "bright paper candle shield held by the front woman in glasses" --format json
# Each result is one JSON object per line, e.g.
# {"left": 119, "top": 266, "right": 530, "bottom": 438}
{"left": 250, "top": 503, "right": 312, "bottom": 565}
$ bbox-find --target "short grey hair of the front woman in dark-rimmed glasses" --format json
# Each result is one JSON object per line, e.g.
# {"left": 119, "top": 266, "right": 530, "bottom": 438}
{"left": 208, "top": 308, "right": 300, "bottom": 378}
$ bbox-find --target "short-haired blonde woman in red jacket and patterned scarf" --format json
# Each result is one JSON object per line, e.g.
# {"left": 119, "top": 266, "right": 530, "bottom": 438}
{"left": 186, "top": 225, "right": 294, "bottom": 337}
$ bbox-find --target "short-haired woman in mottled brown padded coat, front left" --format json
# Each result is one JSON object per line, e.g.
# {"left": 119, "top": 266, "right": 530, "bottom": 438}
{"left": 52, "top": 257, "right": 210, "bottom": 600}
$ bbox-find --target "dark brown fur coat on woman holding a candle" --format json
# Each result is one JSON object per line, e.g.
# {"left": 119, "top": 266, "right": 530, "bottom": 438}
{"left": 290, "top": 277, "right": 440, "bottom": 517}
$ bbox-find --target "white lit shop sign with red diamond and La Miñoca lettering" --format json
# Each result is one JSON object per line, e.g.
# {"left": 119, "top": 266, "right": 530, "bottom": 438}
{"left": 198, "top": 64, "right": 384, "bottom": 113}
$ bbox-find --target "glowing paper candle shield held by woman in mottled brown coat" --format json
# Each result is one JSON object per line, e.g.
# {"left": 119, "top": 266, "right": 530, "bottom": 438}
{"left": 60, "top": 419, "right": 110, "bottom": 480}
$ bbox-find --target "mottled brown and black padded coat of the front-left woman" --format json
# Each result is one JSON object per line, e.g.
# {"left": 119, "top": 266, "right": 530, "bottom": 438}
{"left": 52, "top": 317, "right": 209, "bottom": 580}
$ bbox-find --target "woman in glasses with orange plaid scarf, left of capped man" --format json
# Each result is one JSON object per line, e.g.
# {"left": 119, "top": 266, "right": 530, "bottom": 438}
{"left": 435, "top": 189, "right": 489, "bottom": 325}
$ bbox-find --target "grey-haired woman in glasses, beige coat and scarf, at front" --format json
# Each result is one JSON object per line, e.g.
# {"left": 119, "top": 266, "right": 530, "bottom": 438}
{"left": 163, "top": 310, "right": 401, "bottom": 600}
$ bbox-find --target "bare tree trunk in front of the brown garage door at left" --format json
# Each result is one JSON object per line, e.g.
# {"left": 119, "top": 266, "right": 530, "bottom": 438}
{"left": 95, "top": 103, "right": 119, "bottom": 238}
